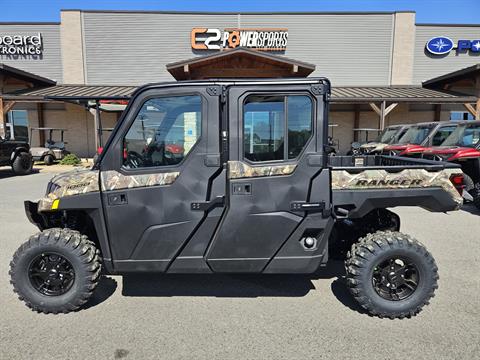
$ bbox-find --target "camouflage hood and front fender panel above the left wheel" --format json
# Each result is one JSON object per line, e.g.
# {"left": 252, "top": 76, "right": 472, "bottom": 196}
{"left": 38, "top": 169, "right": 100, "bottom": 211}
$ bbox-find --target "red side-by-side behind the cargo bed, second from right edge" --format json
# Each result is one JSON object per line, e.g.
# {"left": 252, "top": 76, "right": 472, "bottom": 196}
{"left": 383, "top": 121, "right": 458, "bottom": 157}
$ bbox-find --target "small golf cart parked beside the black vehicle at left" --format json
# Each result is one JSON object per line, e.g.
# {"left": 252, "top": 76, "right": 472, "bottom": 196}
{"left": 30, "top": 128, "right": 70, "bottom": 166}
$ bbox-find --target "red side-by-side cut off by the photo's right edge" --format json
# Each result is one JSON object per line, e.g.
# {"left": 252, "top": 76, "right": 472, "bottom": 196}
{"left": 423, "top": 121, "right": 480, "bottom": 209}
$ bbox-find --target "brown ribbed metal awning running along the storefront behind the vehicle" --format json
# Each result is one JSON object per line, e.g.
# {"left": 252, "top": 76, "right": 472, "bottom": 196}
{"left": 2, "top": 85, "right": 476, "bottom": 104}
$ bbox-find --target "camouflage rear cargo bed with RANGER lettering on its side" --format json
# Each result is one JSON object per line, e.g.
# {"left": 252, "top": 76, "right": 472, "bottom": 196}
{"left": 329, "top": 155, "right": 463, "bottom": 218}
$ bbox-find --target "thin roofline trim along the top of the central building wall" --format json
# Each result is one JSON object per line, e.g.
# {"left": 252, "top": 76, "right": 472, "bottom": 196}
{"left": 60, "top": 9, "right": 416, "bottom": 15}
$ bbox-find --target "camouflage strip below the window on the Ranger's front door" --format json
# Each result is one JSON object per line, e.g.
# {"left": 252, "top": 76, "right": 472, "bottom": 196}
{"left": 100, "top": 170, "right": 180, "bottom": 191}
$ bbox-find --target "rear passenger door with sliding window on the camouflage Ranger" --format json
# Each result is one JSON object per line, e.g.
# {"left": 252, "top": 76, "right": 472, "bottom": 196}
{"left": 207, "top": 86, "right": 329, "bottom": 272}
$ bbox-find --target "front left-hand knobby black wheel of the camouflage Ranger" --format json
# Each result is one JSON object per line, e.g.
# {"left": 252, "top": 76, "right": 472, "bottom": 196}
{"left": 10, "top": 229, "right": 101, "bottom": 314}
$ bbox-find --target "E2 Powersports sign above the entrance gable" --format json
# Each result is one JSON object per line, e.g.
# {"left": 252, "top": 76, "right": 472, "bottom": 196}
{"left": 190, "top": 28, "right": 288, "bottom": 51}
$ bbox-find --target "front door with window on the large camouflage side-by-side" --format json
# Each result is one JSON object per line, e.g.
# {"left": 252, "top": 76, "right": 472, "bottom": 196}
{"left": 100, "top": 86, "right": 223, "bottom": 271}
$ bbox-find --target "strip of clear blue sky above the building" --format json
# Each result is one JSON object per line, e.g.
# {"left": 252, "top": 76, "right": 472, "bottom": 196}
{"left": 0, "top": 0, "right": 480, "bottom": 24}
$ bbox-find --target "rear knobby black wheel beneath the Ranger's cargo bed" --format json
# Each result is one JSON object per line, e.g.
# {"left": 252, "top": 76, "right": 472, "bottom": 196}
{"left": 345, "top": 231, "right": 438, "bottom": 319}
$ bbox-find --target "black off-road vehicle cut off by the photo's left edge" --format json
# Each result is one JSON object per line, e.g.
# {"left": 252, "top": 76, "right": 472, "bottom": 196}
{"left": 0, "top": 136, "right": 33, "bottom": 175}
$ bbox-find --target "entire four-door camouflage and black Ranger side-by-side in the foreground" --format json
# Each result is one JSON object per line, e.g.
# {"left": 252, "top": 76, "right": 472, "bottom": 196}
{"left": 10, "top": 78, "right": 463, "bottom": 318}
